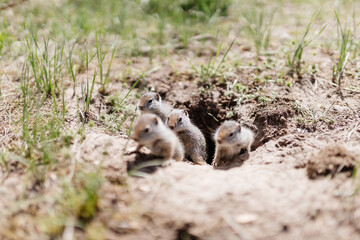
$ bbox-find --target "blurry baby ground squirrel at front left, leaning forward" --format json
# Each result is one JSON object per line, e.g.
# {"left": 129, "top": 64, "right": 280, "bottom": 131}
{"left": 132, "top": 113, "right": 184, "bottom": 161}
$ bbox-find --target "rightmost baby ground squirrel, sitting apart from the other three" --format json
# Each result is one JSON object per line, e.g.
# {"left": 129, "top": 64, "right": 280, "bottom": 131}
{"left": 212, "top": 121, "right": 254, "bottom": 166}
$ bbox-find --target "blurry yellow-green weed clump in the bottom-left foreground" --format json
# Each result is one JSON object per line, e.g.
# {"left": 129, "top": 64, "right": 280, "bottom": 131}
{"left": 39, "top": 171, "right": 103, "bottom": 237}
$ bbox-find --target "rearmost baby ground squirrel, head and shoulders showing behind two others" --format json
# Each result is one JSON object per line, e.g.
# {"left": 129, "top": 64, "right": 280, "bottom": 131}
{"left": 138, "top": 92, "right": 171, "bottom": 122}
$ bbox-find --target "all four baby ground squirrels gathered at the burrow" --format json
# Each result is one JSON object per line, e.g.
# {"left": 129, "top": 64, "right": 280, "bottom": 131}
{"left": 130, "top": 92, "right": 254, "bottom": 166}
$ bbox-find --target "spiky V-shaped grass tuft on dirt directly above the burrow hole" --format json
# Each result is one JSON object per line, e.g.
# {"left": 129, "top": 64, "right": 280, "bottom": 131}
{"left": 184, "top": 40, "right": 235, "bottom": 83}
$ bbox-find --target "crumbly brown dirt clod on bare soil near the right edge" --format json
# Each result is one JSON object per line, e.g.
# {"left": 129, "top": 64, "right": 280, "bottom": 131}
{"left": 307, "top": 145, "right": 356, "bottom": 179}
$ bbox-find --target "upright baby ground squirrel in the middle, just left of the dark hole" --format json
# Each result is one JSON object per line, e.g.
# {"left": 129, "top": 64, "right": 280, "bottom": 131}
{"left": 166, "top": 109, "right": 207, "bottom": 165}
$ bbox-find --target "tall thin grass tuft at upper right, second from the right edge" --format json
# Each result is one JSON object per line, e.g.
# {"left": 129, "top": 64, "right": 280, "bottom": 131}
{"left": 288, "top": 11, "right": 326, "bottom": 78}
